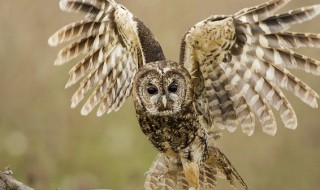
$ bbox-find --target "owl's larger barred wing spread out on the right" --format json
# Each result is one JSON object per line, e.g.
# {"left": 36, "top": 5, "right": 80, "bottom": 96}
{"left": 180, "top": 0, "right": 320, "bottom": 135}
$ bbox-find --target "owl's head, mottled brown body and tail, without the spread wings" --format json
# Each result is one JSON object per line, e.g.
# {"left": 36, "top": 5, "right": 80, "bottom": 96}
{"left": 133, "top": 61, "right": 247, "bottom": 190}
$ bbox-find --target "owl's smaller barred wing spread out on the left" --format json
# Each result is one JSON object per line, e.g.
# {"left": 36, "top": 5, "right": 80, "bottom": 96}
{"left": 48, "top": 0, "right": 165, "bottom": 116}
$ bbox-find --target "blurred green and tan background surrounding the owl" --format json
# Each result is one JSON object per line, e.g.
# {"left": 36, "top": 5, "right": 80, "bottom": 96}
{"left": 0, "top": 0, "right": 320, "bottom": 190}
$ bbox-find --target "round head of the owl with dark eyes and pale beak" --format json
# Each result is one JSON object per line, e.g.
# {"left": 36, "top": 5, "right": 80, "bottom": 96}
{"left": 133, "top": 61, "right": 193, "bottom": 116}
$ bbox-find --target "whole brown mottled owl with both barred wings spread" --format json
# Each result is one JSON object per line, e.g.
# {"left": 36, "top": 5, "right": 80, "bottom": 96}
{"left": 48, "top": 0, "right": 320, "bottom": 189}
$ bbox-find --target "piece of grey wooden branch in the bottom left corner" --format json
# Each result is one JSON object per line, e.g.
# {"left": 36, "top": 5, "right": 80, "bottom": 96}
{"left": 0, "top": 167, "right": 34, "bottom": 190}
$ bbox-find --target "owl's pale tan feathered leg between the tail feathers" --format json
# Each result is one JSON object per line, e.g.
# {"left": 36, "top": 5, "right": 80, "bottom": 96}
{"left": 181, "top": 158, "right": 200, "bottom": 190}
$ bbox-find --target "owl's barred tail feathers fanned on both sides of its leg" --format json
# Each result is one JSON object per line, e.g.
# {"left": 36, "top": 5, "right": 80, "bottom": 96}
{"left": 144, "top": 147, "right": 248, "bottom": 190}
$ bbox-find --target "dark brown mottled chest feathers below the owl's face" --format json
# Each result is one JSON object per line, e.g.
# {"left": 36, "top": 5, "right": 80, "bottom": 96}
{"left": 139, "top": 113, "right": 200, "bottom": 152}
